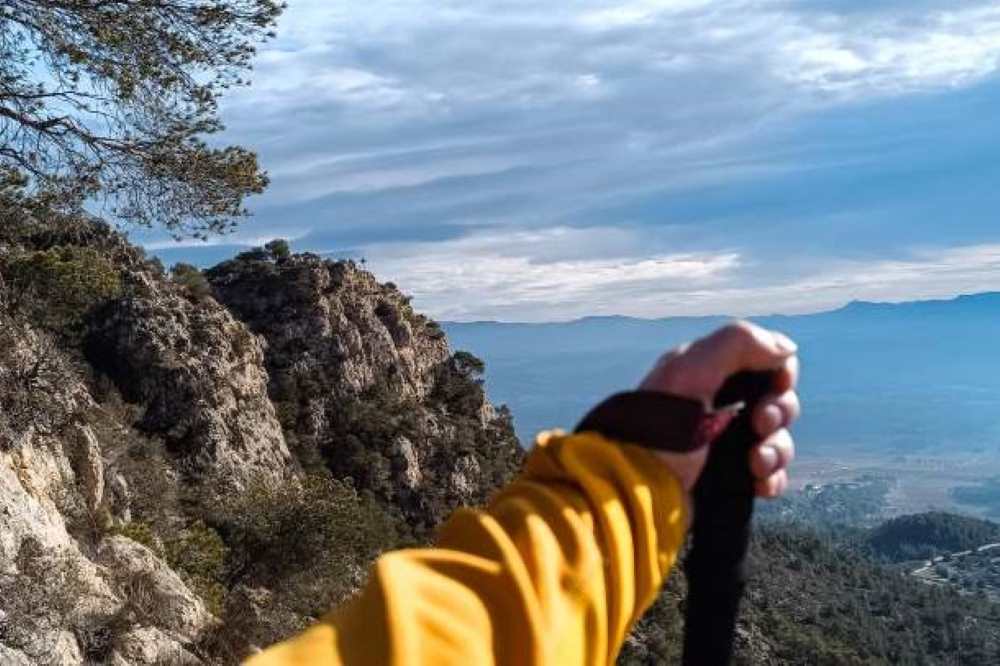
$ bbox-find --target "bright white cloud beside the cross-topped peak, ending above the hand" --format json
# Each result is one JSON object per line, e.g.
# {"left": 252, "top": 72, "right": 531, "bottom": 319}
{"left": 365, "top": 228, "right": 740, "bottom": 320}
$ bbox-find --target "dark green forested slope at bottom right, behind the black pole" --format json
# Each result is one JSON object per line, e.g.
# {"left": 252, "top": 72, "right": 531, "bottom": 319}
{"left": 619, "top": 524, "right": 1000, "bottom": 666}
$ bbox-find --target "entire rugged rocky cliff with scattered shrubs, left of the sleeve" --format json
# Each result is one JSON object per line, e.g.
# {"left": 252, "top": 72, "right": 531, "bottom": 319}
{"left": 0, "top": 209, "right": 521, "bottom": 665}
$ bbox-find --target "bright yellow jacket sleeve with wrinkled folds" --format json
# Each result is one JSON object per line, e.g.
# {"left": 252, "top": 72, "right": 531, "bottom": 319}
{"left": 249, "top": 432, "right": 687, "bottom": 666}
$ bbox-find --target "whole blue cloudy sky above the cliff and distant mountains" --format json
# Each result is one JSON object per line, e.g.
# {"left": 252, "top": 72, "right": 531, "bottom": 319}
{"left": 138, "top": 0, "right": 1000, "bottom": 321}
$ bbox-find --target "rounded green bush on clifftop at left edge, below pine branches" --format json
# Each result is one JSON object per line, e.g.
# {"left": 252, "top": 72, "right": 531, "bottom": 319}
{"left": 0, "top": 245, "right": 122, "bottom": 332}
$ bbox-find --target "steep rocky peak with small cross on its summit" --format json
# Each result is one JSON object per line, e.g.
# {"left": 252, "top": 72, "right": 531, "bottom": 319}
{"left": 207, "top": 254, "right": 521, "bottom": 529}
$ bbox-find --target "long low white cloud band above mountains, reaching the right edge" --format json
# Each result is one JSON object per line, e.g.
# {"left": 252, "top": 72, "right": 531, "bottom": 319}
{"left": 364, "top": 228, "right": 1000, "bottom": 321}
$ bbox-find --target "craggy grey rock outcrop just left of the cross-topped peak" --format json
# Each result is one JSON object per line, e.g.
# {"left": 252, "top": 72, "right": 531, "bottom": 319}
{"left": 88, "top": 286, "right": 294, "bottom": 492}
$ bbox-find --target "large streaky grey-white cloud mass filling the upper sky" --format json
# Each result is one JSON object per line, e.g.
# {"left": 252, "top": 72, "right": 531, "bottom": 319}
{"left": 225, "top": 0, "right": 1000, "bottom": 214}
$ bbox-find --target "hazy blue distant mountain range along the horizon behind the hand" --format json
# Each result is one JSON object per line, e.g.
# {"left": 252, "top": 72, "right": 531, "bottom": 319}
{"left": 444, "top": 293, "right": 1000, "bottom": 455}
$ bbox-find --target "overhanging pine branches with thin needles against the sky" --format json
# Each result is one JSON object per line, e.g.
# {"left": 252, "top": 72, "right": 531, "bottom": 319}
{"left": 0, "top": 0, "right": 284, "bottom": 236}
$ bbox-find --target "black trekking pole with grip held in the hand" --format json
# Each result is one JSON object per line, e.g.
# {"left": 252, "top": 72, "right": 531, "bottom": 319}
{"left": 683, "top": 372, "right": 774, "bottom": 666}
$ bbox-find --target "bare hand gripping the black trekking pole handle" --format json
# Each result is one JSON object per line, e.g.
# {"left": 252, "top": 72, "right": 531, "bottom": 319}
{"left": 640, "top": 321, "right": 800, "bottom": 498}
